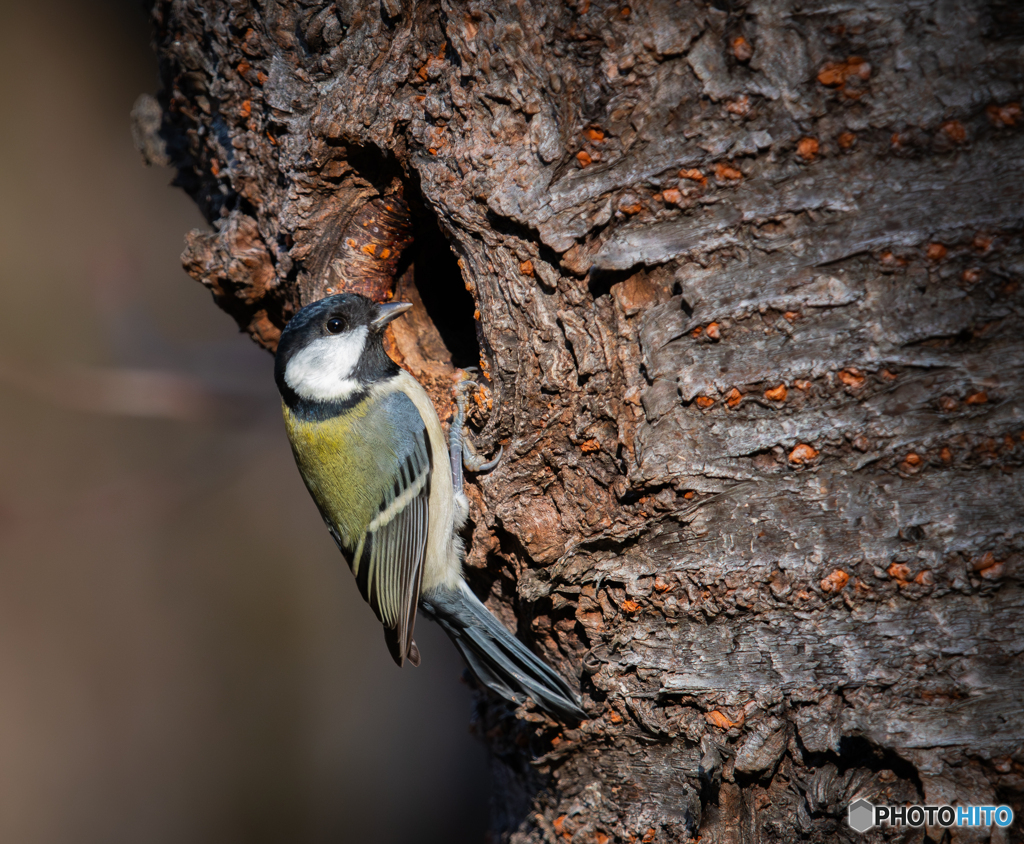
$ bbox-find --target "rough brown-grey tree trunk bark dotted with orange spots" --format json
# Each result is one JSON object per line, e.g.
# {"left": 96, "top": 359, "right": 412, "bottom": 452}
{"left": 135, "top": 0, "right": 1024, "bottom": 844}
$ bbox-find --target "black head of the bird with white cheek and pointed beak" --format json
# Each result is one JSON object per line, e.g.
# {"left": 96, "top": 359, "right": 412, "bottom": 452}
{"left": 274, "top": 293, "right": 412, "bottom": 403}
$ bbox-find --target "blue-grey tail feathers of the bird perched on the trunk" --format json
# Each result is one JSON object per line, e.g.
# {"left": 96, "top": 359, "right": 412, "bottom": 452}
{"left": 420, "top": 583, "right": 587, "bottom": 721}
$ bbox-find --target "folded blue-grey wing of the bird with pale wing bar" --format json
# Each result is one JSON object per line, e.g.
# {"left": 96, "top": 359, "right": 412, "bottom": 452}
{"left": 343, "top": 391, "right": 433, "bottom": 666}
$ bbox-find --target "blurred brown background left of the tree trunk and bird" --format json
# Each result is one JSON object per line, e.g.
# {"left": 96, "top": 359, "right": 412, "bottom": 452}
{"left": 0, "top": 0, "right": 489, "bottom": 844}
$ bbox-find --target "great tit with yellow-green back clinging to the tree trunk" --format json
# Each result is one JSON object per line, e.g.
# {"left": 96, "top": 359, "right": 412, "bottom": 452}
{"left": 274, "top": 293, "right": 586, "bottom": 720}
